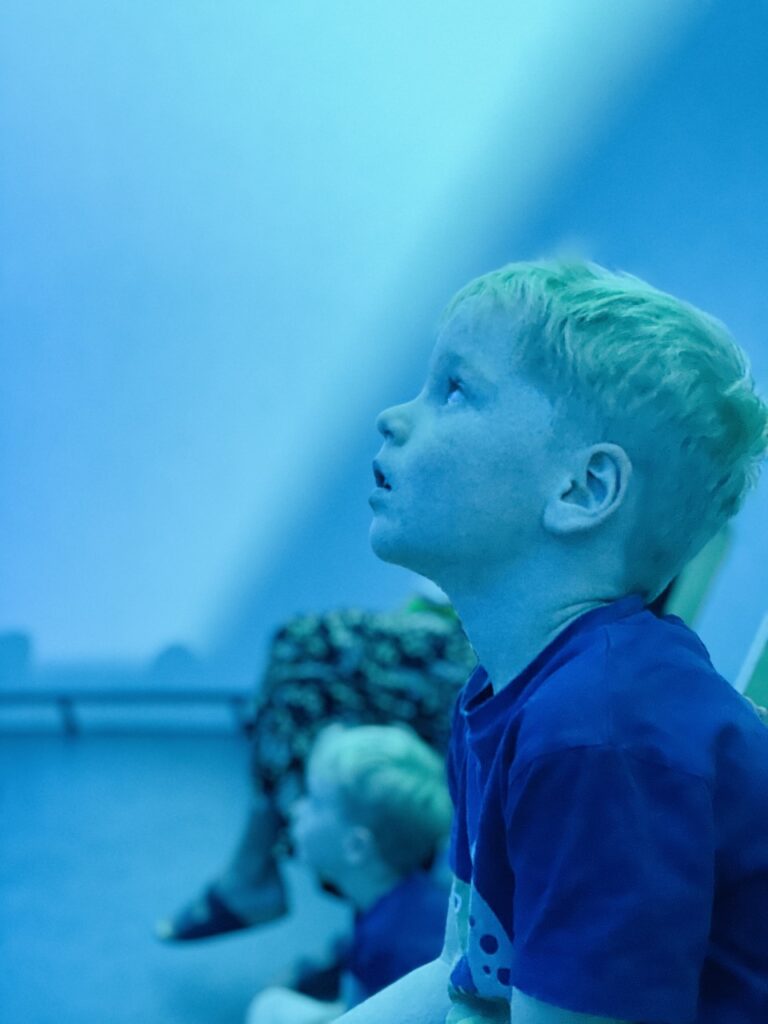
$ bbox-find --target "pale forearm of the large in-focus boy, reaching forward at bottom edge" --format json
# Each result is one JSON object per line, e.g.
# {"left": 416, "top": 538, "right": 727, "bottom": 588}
{"left": 337, "top": 887, "right": 461, "bottom": 1024}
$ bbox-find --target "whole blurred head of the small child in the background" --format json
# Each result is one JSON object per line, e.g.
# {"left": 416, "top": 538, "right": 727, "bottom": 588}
{"left": 292, "top": 725, "right": 452, "bottom": 892}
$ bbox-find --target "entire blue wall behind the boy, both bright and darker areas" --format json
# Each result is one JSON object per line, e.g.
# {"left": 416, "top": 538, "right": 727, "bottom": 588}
{"left": 0, "top": 6, "right": 768, "bottom": 679}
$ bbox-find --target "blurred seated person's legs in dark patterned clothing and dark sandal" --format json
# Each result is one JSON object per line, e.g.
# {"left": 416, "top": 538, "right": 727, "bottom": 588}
{"left": 157, "top": 597, "right": 475, "bottom": 941}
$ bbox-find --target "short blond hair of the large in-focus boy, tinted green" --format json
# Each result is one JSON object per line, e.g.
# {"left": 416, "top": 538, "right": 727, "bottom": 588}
{"left": 443, "top": 260, "right": 768, "bottom": 599}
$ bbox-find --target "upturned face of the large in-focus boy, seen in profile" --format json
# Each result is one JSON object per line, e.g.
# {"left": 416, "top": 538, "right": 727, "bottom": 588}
{"left": 370, "top": 302, "right": 562, "bottom": 586}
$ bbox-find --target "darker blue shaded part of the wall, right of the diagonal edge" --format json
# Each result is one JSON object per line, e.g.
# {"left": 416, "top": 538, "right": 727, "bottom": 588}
{"left": 215, "top": 2, "right": 768, "bottom": 679}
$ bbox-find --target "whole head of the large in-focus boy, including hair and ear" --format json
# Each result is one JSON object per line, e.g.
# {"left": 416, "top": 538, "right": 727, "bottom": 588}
{"left": 371, "top": 261, "right": 768, "bottom": 599}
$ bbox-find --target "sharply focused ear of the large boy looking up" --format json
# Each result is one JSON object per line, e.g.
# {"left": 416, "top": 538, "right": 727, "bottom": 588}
{"left": 544, "top": 442, "right": 632, "bottom": 535}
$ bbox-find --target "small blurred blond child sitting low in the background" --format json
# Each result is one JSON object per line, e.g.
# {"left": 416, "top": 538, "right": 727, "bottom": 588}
{"left": 248, "top": 725, "right": 452, "bottom": 1024}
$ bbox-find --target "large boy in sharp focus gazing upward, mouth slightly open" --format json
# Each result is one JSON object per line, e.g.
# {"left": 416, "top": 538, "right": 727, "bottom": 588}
{"left": 343, "top": 262, "right": 768, "bottom": 1024}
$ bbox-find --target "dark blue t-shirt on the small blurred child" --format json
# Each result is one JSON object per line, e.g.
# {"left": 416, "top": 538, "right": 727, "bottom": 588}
{"left": 345, "top": 871, "right": 447, "bottom": 1001}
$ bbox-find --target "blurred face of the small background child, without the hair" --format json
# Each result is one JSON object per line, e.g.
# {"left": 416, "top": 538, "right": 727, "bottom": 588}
{"left": 291, "top": 769, "right": 353, "bottom": 884}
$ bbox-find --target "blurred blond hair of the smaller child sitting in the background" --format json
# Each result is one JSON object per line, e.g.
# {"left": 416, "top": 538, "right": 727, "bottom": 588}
{"left": 308, "top": 725, "right": 452, "bottom": 877}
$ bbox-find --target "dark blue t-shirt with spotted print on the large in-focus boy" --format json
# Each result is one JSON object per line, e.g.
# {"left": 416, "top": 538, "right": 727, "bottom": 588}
{"left": 449, "top": 596, "right": 768, "bottom": 1024}
